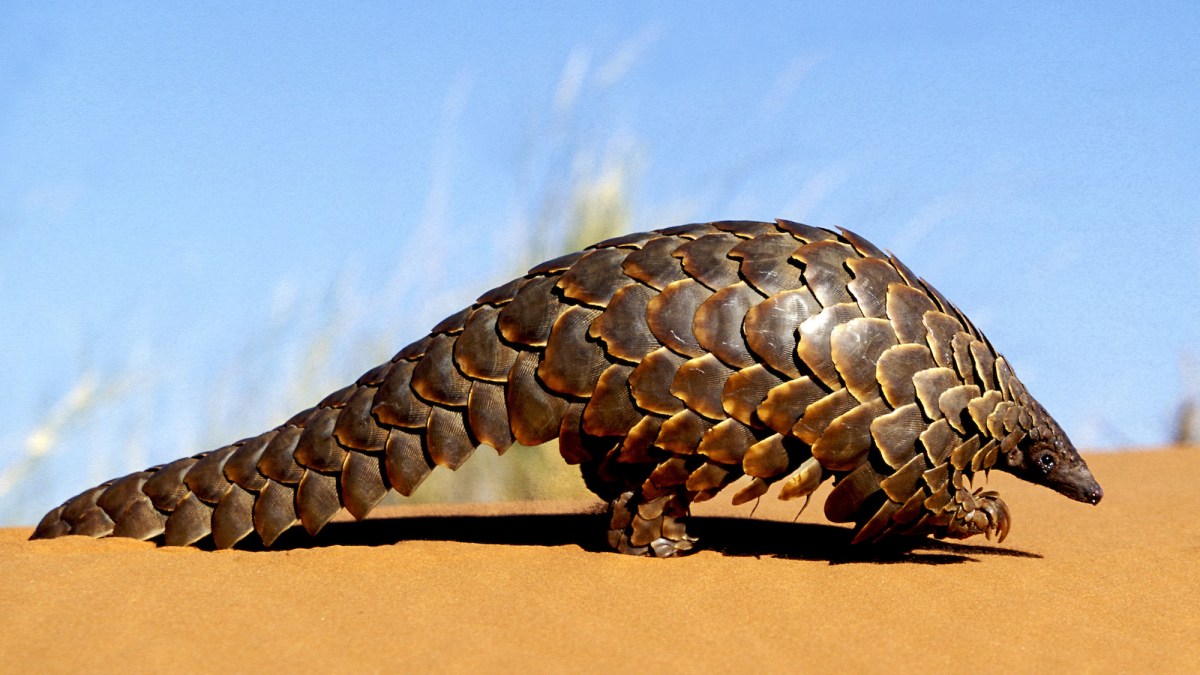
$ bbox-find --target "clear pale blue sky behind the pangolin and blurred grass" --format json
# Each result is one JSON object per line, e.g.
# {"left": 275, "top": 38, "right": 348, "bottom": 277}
{"left": 0, "top": 2, "right": 1200, "bottom": 521}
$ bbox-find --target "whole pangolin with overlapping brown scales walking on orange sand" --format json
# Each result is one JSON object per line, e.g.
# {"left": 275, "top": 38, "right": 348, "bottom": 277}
{"left": 32, "top": 220, "right": 1103, "bottom": 557}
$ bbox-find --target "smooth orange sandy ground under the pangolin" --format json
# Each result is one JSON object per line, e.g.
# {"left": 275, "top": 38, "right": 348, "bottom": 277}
{"left": 0, "top": 449, "right": 1200, "bottom": 673}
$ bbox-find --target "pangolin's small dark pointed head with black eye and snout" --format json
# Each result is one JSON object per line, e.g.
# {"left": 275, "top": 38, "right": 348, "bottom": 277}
{"left": 997, "top": 399, "right": 1104, "bottom": 504}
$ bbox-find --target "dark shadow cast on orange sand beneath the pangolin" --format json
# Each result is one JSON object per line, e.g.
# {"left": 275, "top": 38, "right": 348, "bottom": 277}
{"left": 225, "top": 514, "right": 1042, "bottom": 565}
